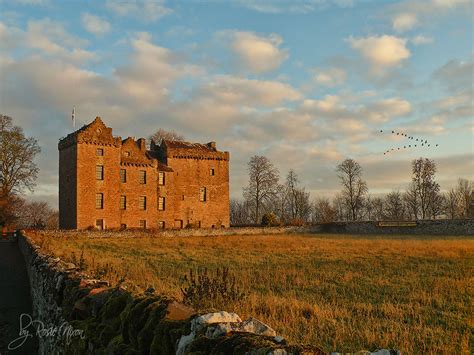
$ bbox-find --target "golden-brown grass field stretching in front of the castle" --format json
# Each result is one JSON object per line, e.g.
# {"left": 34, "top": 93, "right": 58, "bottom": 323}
{"left": 33, "top": 234, "right": 474, "bottom": 354}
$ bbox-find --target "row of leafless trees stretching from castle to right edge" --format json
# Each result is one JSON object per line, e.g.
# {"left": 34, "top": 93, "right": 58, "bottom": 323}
{"left": 230, "top": 156, "right": 474, "bottom": 225}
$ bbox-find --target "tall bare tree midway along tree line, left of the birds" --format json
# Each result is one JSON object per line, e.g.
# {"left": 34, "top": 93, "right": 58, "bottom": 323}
{"left": 336, "top": 159, "right": 368, "bottom": 221}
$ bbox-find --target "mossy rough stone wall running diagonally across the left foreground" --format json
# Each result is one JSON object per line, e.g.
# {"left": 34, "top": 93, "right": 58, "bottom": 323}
{"left": 18, "top": 234, "right": 323, "bottom": 355}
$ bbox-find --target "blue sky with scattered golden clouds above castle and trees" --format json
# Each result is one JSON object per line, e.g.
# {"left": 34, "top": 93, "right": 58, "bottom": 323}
{"left": 0, "top": 0, "right": 474, "bottom": 207}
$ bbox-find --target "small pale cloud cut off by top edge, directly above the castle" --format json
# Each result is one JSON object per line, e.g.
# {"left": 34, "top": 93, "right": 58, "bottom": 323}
{"left": 105, "top": 0, "right": 173, "bottom": 22}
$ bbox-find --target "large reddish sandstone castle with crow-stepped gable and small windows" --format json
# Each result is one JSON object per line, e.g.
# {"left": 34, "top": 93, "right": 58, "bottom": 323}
{"left": 58, "top": 117, "right": 229, "bottom": 229}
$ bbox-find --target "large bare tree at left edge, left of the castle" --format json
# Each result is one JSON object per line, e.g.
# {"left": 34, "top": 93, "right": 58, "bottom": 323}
{"left": 0, "top": 115, "right": 41, "bottom": 198}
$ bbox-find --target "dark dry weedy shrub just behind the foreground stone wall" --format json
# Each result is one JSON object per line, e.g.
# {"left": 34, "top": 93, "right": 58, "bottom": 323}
{"left": 181, "top": 267, "right": 248, "bottom": 309}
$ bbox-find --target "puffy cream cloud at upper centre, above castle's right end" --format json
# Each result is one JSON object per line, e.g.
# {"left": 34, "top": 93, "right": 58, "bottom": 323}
{"left": 225, "top": 31, "right": 289, "bottom": 74}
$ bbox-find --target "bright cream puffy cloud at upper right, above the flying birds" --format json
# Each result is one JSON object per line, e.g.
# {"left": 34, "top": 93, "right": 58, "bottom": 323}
{"left": 347, "top": 35, "right": 411, "bottom": 68}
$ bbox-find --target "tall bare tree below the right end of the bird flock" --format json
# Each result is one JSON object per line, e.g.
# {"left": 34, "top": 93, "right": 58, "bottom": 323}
{"left": 412, "top": 158, "right": 439, "bottom": 219}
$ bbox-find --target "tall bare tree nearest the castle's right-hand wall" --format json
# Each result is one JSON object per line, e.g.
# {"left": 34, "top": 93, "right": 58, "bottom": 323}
{"left": 244, "top": 155, "right": 280, "bottom": 224}
